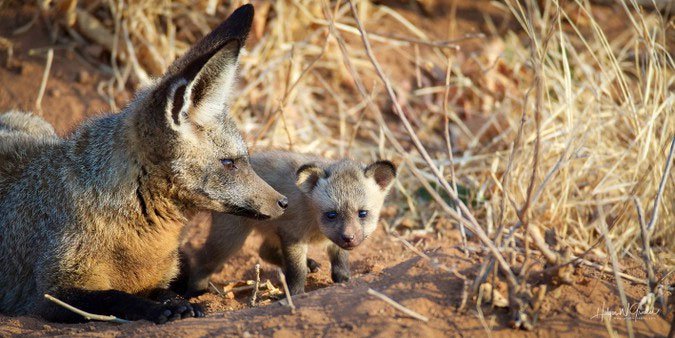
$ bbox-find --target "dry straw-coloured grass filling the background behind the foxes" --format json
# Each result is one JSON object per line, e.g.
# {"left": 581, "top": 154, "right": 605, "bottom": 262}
{"left": 26, "top": 0, "right": 675, "bottom": 328}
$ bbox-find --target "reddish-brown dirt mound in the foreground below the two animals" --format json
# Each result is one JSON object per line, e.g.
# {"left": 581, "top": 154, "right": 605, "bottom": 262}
{"left": 0, "top": 229, "right": 669, "bottom": 337}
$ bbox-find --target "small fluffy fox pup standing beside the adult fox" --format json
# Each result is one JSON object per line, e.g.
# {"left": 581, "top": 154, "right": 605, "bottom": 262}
{"left": 184, "top": 151, "right": 396, "bottom": 295}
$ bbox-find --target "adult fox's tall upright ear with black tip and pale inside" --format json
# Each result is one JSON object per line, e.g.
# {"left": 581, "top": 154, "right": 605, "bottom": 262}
{"left": 160, "top": 4, "right": 253, "bottom": 129}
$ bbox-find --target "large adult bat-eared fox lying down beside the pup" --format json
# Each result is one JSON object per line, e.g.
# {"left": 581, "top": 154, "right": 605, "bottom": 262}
{"left": 0, "top": 5, "right": 286, "bottom": 322}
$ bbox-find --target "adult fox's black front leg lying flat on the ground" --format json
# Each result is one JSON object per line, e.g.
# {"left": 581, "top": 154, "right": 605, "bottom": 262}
{"left": 38, "top": 288, "right": 201, "bottom": 324}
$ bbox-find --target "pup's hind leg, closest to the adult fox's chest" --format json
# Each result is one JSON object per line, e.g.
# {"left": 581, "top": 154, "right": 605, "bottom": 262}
{"left": 184, "top": 213, "right": 253, "bottom": 297}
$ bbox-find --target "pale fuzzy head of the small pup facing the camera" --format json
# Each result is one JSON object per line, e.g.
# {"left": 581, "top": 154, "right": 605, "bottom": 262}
{"left": 296, "top": 160, "right": 396, "bottom": 250}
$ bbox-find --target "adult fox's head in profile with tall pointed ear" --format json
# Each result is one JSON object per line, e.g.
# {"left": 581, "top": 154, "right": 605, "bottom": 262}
{"left": 131, "top": 5, "right": 287, "bottom": 218}
